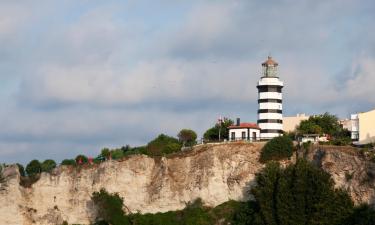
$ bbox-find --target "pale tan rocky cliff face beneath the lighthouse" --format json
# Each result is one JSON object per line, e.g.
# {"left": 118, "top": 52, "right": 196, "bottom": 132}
{"left": 0, "top": 143, "right": 375, "bottom": 225}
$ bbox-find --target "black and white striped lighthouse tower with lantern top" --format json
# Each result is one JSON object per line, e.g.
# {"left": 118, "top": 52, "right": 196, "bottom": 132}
{"left": 257, "top": 56, "right": 284, "bottom": 140}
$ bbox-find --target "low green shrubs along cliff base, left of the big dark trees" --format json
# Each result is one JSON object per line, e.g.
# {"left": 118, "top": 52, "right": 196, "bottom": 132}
{"left": 92, "top": 190, "right": 245, "bottom": 225}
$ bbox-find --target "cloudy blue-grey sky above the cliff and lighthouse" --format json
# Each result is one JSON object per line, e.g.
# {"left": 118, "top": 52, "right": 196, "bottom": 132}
{"left": 0, "top": 0, "right": 375, "bottom": 164}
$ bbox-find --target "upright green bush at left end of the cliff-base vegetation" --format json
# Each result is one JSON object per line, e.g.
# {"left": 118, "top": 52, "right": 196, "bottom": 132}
{"left": 91, "top": 189, "right": 130, "bottom": 225}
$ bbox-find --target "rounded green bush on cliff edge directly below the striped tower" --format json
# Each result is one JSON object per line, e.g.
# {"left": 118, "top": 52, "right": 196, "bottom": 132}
{"left": 260, "top": 136, "right": 293, "bottom": 163}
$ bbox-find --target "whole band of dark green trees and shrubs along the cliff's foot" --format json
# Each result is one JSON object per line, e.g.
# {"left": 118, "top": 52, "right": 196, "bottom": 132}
{"left": 92, "top": 160, "right": 375, "bottom": 225}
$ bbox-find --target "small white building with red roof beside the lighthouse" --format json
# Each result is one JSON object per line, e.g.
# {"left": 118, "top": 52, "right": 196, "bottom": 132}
{"left": 228, "top": 118, "right": 260, "bottom": 142}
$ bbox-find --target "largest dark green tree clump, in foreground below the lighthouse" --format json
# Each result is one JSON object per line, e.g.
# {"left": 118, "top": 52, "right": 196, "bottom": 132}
{"left": 237, "top": 160, "right": 353, "bottom": 225}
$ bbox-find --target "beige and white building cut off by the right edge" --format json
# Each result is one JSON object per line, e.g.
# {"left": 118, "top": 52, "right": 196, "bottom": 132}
{"left": 350, "top": 109, "right": 375, "bottom": 145}
